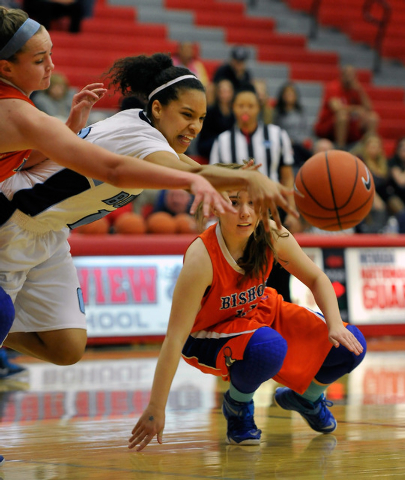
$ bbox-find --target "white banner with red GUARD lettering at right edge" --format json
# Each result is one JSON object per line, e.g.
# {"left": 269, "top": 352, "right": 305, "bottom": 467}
{"left": 345, "top": 248, "right": 405, "bottom": 325}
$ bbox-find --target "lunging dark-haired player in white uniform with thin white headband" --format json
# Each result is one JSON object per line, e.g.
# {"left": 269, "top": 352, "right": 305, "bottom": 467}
{"left": 0, "top": 50, "right": 296, "bottom": 388}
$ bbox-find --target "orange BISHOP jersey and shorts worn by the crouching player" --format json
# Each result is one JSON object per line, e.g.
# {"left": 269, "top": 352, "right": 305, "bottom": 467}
{"left": 183, "top": 225, "right": 332, "bottom": 393}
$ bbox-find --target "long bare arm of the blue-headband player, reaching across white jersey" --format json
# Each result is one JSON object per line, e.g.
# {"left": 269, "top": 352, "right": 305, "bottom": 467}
{"left": 0, "top": 99, "right": 233, "bottom": 215}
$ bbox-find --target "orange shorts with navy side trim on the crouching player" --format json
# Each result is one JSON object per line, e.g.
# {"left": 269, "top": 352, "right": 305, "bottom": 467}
{"left": 183, "top": 287, "right": 340, "bottom": 393}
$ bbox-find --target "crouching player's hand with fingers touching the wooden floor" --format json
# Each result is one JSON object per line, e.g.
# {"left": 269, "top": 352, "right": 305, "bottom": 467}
{"left": 128, "top": 407, "right": 165, "bottom": 452}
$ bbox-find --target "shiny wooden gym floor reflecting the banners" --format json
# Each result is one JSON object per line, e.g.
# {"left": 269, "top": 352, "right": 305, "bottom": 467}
{"left": 0, "top": 340, "right": 405, "bottom": 480}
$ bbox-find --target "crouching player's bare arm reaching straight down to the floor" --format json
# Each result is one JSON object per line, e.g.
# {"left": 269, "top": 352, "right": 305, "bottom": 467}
{"left": 128, "top": 239, "right": 212, "bottom": 451}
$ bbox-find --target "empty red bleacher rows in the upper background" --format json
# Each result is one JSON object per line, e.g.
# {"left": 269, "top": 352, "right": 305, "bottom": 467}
{"left": 48, "top": 0, "right": 405, "bottom": 153}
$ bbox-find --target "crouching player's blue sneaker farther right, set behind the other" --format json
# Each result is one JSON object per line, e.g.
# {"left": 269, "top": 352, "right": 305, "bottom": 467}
{"left": 274, "top": 387, "right": 337, "bottom": 433}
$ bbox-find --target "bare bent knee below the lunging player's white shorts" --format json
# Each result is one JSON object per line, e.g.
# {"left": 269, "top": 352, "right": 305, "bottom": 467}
{"left": 4, "top": 328, "right": 87, "bottom": 365}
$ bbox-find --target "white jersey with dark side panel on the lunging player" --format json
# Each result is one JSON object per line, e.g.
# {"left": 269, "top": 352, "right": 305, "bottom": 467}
{"left": 0, "top": 109, "right": 177, "bottom": 233}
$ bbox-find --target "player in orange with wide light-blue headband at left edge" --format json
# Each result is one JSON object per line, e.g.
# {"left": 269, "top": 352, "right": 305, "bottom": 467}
{"left": 0, "top": 7, "right": 296, "bottom": 364}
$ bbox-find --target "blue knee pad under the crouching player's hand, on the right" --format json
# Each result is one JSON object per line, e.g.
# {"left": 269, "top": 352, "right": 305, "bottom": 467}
{"left": 315, "top": 325, "right": 367, "bottom": 384}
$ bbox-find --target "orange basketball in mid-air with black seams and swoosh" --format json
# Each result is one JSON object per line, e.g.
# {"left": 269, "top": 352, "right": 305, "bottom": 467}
{"left": 294, "top": 150, "right": 375, "bottom": 231}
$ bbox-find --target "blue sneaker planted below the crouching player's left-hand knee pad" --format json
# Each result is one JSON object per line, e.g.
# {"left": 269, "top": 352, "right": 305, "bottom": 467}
{"left": 222, "top": 390, "right": 262, "bottom": 445}
